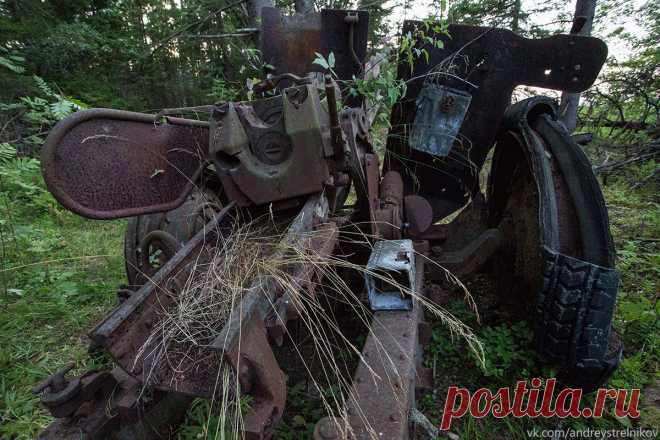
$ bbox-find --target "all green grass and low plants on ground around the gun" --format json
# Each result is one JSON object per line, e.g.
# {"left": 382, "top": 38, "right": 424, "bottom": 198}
{"left": 0, "top": 166, "right": 660, "bottom": 439}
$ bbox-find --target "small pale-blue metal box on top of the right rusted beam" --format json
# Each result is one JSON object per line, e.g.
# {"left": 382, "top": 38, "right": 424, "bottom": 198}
{"left": 365, "top": 240, "right": 417, "bottom": 311}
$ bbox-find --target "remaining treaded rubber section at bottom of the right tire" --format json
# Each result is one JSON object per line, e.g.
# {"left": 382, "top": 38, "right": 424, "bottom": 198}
{"left": 535, "top": 249, "right": 623, "bottom": 392}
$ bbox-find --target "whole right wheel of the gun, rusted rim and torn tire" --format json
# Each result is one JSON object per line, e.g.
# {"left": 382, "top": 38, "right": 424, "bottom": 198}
{"left": 488, "top": 103, "right": 621, "bottom": 391}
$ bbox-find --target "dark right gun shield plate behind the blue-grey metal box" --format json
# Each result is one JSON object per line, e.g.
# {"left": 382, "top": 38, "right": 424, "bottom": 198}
{"left": 385, "top": 21, "right": 607, "bottom": 220}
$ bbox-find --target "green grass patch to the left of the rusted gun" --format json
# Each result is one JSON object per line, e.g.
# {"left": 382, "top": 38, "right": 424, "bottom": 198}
{"left": 0, "top": 176, "right": 124, "bottom": 439}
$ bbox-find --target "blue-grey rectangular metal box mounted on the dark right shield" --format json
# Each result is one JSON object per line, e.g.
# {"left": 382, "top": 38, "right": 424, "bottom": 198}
{"left": 409, "top": 82, "right": 472, "bottom": 157}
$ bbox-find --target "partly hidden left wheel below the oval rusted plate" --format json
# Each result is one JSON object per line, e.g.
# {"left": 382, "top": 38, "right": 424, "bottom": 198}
{"left": 124, "top": 189, "right": 222, "bottom": 288}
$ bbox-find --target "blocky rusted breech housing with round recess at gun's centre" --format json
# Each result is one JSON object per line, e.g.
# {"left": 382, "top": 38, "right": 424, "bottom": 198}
{"left": 210, "top": 85, "right": 329, "bottom": 206}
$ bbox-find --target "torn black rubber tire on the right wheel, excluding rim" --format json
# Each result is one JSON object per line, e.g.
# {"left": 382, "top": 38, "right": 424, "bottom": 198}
{"left": 489, "top": 98, "right": 623, "bottom": 392}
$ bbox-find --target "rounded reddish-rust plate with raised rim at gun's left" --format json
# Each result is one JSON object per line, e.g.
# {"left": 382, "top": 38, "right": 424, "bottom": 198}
{"left": 42, "top": 109, "right": 208, "bottom": 219}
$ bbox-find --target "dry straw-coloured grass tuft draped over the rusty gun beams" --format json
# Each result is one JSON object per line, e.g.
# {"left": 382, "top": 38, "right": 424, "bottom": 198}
{"left": 136, "top": 211, "right": 483, "bottom": 439}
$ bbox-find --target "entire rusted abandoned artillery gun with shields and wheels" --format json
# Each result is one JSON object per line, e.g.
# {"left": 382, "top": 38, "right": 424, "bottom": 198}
{"left": 37, "top": 8, "right": 621, "bottom": 439}
